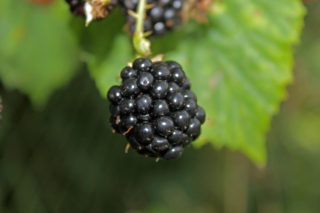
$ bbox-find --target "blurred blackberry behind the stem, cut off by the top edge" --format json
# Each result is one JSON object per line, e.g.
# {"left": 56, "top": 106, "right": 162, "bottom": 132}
{"left": 119, "top": 0, "right": 184, "bottom": 36}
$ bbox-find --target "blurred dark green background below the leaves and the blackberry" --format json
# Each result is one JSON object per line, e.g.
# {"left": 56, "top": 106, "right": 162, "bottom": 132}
{"left": 0, "top": 1, "right": 320, "bottom": 213}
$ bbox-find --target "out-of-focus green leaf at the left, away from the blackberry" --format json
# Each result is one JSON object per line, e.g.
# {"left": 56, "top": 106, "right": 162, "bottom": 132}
{"left": 0, "top": 0, "right": 78, "bottom": 106}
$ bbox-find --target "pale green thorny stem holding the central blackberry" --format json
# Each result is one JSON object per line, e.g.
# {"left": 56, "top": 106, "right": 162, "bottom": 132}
{"left": 133, "top": 0, "right": 151, "bottom": 56}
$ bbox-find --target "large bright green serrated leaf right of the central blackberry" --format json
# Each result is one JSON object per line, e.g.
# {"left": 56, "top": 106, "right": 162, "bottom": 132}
{"left": 155, "top": 0, "right": 305, "bottom": 165}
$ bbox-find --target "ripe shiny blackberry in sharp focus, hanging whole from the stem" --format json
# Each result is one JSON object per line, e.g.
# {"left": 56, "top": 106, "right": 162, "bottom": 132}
{"left": 108, "top": 58, "right": 205, "bottom": 160}
